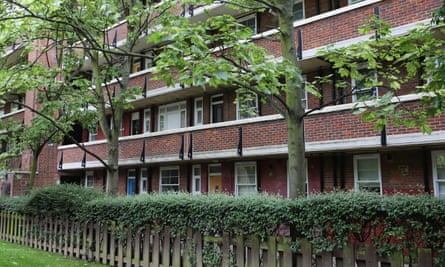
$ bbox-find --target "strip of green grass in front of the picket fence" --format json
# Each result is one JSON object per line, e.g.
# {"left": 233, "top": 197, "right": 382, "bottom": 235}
{"left": 0, "top": 240, "right": 108, "bottom": 267}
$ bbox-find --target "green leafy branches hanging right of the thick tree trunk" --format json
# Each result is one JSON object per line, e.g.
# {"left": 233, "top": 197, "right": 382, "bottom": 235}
{"left": 319, "top": 17, "right": 445, "bottom": 133}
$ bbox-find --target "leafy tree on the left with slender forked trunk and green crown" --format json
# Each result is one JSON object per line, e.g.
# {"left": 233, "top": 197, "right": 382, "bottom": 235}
{"left": 0, "top": 0, "right": 172, "bottom": 195}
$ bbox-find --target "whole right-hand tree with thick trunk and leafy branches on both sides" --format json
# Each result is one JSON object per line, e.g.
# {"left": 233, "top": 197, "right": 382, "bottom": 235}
{"left": 148, "top": 0, "right": 444, "bottom": 198}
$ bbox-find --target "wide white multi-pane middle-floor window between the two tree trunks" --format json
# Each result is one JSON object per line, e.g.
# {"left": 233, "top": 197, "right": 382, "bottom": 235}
{"left": 159, "top": 101, "right": 186, "bottom": 131}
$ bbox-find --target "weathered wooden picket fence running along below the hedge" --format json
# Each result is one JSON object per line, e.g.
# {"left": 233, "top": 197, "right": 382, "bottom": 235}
{"left": 0, "top": 211, "right": 436, "bottom": 267}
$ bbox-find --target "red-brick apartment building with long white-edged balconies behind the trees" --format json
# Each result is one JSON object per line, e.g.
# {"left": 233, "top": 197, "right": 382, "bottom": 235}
{"left": 0, "top": 0, "right": 445, "bottom": 196}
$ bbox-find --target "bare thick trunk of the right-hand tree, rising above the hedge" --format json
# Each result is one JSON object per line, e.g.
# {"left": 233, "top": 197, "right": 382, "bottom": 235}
{"left": 276, "top": 0, "right": 306, "bottom": 198}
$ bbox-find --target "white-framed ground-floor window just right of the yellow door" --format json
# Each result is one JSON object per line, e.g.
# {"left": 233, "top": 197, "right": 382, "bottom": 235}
{"left": 235, "top": 162, "right": 257, "bottom": 196}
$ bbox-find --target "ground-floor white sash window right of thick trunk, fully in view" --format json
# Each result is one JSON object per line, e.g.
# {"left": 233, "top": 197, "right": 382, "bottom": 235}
{"left": 354, "top": 154, "right": 382, "bottom": 194}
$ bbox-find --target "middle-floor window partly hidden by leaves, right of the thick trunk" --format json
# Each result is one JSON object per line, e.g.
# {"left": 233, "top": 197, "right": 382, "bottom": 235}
{"left": 351, "top": 64, "right": 378, "bottom": 102}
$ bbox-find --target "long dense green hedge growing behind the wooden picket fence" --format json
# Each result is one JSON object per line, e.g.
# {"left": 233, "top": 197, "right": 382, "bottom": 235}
{"left": 0, "top": 185, "right": 445, "bottom": 253}
